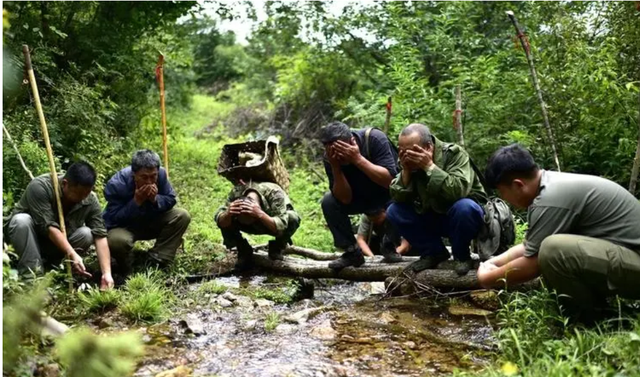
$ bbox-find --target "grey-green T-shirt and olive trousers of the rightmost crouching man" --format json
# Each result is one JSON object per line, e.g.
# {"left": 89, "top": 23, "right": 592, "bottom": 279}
{"left": 524, "top": 170, "right": 640, "bottom": 320}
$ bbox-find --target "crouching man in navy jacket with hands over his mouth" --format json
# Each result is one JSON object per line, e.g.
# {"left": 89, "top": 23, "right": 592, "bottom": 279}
{"left": 103, "top": 149, "right": 191, "bottom": 276}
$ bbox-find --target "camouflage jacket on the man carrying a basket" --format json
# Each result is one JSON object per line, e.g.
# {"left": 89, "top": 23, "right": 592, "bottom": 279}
{"left": 214, "top": 182, "right": 294, "bottom": 235}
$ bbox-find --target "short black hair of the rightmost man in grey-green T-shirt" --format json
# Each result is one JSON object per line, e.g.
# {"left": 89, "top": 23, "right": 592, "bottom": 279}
{"left": 484, "top": 144, "right": 540, "bottom": 188}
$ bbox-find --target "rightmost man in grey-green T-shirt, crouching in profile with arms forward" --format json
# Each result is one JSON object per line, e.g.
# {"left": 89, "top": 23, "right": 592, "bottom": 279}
{"left": 478, "top": 145, "right": 640, "bottom": 323}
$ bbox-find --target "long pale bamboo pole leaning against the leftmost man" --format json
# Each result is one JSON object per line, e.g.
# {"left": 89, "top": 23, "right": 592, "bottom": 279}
{"left": 22, "top": 45, "right": 73, "bottom": 292}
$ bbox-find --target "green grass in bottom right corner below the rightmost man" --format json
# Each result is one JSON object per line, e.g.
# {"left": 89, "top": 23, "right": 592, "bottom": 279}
{"left": 458, "top": 290, "right": 640, "bottom": 377}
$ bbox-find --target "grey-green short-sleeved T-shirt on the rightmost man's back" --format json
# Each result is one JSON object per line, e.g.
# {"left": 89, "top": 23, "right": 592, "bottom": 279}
{"left": 526, "top": 171, "right": 640, "bottom": 255}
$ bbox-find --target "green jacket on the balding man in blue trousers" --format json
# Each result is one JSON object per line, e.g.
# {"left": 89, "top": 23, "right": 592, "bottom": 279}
{"left": 389, "top": 136, "right": 487, "bottom": 214}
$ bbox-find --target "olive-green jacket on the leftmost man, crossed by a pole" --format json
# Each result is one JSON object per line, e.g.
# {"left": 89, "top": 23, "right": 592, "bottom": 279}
{"left": 12, "top": 174, "right": 107, "bottom": 238}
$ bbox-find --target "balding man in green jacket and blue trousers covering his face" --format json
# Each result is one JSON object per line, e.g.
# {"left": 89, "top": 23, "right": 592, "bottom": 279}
{"left": 387, "top": 123, "right": 487, "bottom": 275}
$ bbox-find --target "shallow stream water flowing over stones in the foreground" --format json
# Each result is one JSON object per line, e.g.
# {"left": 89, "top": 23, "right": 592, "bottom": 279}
{"left": 129, "top": 277, "right": 494, "bottom": 377}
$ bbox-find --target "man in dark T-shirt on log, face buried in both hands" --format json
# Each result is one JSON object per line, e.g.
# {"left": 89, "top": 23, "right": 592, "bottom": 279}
{"left": 320, "top": 122, "right": 402, "bottom": 270}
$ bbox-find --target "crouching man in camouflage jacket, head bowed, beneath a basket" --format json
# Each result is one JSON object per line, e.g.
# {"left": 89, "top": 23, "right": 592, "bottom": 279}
{"left": 214, "top": 182, "right": 300, "bottom": 270}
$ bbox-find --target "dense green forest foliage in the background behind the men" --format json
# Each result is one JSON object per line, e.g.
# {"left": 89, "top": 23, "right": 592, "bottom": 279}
{"left": 3, "top": 2, "right": 640, "bottom": 203}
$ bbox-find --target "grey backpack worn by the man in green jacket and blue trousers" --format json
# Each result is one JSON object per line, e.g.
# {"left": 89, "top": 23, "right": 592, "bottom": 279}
{"left": 469, "top": 157, "right": 516, "bottom": 261}
